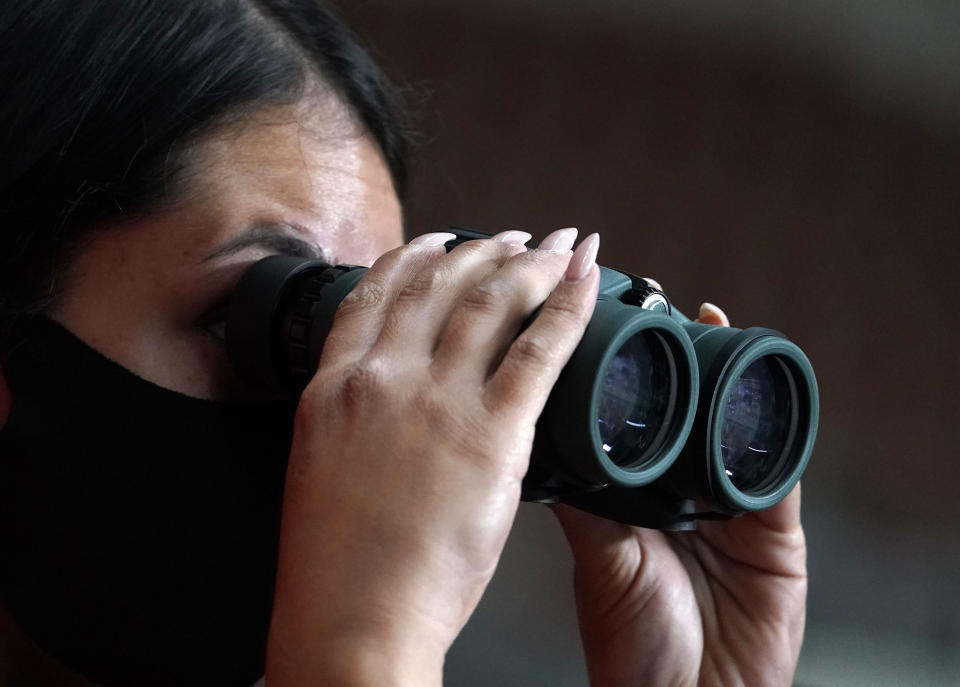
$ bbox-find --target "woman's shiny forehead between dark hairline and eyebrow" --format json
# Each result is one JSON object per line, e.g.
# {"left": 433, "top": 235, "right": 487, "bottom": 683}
{"left": 176, "top": 95, "right": 402, "bottom": 264}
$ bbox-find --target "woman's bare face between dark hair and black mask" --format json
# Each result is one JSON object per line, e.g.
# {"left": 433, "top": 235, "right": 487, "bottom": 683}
{"left": 0, "top": 96, "right": 402, "bottom": 412}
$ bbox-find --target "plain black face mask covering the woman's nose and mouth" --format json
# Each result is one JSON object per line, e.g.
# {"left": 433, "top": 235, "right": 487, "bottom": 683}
{"left": 0, "top": 318, "right": 295, "bottom": 687}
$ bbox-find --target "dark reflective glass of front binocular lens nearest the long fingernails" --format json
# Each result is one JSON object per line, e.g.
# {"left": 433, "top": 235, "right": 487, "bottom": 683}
{"left": 597, "top": 330, "right": 677, "bottom": 469}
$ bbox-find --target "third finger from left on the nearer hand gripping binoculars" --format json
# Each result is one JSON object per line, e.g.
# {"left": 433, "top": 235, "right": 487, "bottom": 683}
{"left": 433, "top": 229, "right": 576, "bottom": 383}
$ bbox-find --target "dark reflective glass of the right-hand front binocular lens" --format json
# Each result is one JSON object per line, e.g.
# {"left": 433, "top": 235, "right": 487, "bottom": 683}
{"left": 720, "top": 356, "right": 797, "bottom": 492}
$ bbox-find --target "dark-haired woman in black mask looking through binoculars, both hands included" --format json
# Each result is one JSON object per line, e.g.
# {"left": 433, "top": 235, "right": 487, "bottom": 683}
{"left": 0, "top": 0, "right": 806, "bottom": 687}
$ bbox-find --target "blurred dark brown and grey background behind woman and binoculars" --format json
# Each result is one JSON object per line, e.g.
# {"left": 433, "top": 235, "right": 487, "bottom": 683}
{"left": 338, "top": 0, "right": 960, "bottom": 686}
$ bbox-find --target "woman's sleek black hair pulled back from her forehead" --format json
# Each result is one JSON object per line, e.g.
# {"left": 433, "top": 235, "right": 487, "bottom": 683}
{"left": 0, "top": 0, "right": 405, "bottom": 327}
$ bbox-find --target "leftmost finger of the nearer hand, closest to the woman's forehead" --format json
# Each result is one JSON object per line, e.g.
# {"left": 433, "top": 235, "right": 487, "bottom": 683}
{"left": 320, "top": 232, "right": 456, "bottom": 366}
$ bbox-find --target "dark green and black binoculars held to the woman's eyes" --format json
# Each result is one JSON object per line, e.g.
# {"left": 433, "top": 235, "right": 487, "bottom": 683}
{"left": 226, "top": 228, "right": 819, "bottom": 530}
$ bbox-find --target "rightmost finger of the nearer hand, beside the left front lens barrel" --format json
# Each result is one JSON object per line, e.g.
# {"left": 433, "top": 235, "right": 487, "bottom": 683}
{"left": 484, "top": 234, "right": 600, "bottom": 414}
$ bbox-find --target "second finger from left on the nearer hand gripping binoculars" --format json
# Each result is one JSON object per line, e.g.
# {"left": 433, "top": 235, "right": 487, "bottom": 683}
{"left": 373, "top": 231, "right": 530, "bottom": 356}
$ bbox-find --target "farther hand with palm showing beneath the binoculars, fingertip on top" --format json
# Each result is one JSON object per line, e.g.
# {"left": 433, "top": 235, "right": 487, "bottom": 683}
{"left": 554, "top": 306, "right": 807, "bottom": 687}
